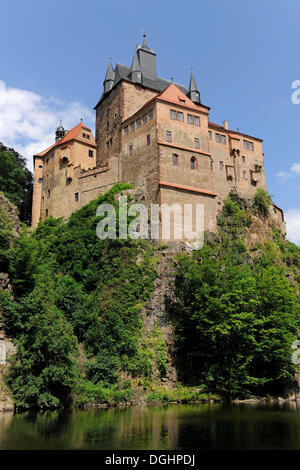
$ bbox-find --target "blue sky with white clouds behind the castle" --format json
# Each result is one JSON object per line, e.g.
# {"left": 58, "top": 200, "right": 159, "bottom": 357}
{"left": 0, "top": 0, "right": 300, "bottom": 244}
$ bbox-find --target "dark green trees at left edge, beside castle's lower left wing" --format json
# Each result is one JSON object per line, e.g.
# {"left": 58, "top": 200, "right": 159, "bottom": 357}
{"left": 0, "top": 143, "right": 33, "bottom": 224}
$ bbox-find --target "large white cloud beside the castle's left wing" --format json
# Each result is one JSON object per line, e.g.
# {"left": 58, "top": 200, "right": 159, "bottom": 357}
{"left": 0, "top": 80, "right": 94, "bottom": 170}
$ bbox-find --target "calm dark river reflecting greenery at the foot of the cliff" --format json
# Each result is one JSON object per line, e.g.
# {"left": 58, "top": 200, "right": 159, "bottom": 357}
{"left": 0, "top": 402, "right": 300, "bottom": 450}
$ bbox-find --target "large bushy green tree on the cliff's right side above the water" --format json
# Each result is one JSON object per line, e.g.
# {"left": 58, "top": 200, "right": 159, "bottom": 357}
{"left": 170, "top": 196, "right": 299, "bottom": 396}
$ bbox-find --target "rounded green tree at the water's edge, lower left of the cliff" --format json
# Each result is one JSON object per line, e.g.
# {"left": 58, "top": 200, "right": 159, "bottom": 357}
{"left": 1, "top": 286, "right": 77, "bottom": 408}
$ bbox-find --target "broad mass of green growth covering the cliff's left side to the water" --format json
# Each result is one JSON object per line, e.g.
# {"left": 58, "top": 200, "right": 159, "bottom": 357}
{"left": 0, "top": 184, "right": 156, "bottom": 407}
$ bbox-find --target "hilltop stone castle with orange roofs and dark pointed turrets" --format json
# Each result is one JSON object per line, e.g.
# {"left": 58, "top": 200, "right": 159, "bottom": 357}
{"left": 32, "top": 35, "right": 284, "bottom": 239}
